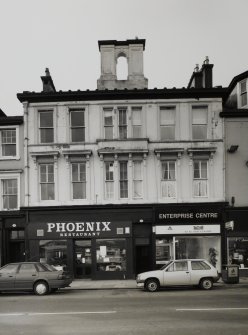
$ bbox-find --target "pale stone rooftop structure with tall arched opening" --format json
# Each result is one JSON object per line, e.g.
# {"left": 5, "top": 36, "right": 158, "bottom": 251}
{"left": 97, "top": 38, "right": 148, "bottom": 90}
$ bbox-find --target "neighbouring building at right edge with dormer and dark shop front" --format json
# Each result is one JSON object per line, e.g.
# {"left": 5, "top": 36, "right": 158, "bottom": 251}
{"left": 221, "top": 71, "right": 248, "bottom": 275}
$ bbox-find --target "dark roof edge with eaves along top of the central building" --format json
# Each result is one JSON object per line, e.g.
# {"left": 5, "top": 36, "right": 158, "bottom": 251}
{"left": 17, "top": 87, "right": 227, "bottom": 103}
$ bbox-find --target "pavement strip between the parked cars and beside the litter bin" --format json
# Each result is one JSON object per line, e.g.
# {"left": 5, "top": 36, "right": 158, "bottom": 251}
{"left": 69, "top": 277, "right": 248, "bottom": 290}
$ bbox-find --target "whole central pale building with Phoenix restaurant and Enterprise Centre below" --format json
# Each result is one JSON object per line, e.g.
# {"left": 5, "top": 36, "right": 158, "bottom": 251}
{"left": 17, "top": 39, "right": 229, "bottom": 279}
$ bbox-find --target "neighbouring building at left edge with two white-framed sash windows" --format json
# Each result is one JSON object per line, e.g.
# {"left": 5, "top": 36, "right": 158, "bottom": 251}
{"left": 0, "top": 109, "right": 25, "bottom": 266}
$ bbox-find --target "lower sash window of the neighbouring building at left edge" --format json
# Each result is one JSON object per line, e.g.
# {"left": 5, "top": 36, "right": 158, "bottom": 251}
{"left": 1, "top": 178, "right": 18, "bottom": 210}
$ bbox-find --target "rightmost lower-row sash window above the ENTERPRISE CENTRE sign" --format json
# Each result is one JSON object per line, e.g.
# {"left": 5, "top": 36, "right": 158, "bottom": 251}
{"left": 193, "top": 160, "right": 208, "bottom": 197}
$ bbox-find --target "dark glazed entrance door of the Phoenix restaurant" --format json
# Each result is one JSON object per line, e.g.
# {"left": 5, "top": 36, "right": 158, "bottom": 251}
{"left": 74, "top": 240, "right": 92, "bottom": 278}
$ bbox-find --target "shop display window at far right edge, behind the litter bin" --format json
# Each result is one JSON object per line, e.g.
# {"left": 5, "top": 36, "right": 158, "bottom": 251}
{"left": 227, "top": 236, "right": 248, "bottom": 269}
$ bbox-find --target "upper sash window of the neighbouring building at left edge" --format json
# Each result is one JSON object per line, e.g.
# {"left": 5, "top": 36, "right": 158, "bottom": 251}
{"left": 0, "top": 129, "right": 16, "bottom": 157}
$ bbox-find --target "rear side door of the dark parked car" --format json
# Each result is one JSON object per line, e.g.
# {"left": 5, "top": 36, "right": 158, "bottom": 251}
{"left": 15, "top": 263, "right": 39, "bottom": 290}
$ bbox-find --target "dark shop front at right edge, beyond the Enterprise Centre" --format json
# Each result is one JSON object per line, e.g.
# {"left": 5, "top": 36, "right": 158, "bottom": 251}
{"left": 225, "top": 207, "right": 248, "bottom": 277}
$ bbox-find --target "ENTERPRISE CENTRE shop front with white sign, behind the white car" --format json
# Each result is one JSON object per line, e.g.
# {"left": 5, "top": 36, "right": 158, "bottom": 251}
{"left": 153, "top": 204, "right": 223, "bottom": 272}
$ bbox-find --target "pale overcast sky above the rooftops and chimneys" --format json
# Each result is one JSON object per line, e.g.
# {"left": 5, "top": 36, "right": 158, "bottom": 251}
{"left": 0, "top": 0, "right": 248, "bottom": 116}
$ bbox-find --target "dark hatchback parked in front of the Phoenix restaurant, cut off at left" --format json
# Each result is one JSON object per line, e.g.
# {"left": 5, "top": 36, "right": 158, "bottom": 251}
{"left": 0, "top": 262, "right": 72, "bottom": 295}
